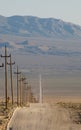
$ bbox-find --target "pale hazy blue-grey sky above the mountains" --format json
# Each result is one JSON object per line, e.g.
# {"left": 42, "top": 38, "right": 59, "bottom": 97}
{"left": 0, "top": 0, "right": 81, "bottom": 25}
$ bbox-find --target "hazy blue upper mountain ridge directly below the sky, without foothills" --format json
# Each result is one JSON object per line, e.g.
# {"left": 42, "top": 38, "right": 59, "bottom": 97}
{"left": 0, "top": 16, "right": 81, "bottom": 39}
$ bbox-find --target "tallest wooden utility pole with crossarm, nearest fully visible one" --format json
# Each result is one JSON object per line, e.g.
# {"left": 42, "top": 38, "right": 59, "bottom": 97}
{"left": 1, "top": 46, "right": 10, "bottom": 109}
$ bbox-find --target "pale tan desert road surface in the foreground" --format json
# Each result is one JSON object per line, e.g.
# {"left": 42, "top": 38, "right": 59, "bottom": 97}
{"left": 7, "top": 104, "right": 81, "bottom": 130}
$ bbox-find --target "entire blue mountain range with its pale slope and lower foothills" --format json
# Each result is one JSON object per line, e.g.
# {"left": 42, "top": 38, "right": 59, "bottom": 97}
{"left": 0, "top": 16, "right": 81, "bottom": 55}
